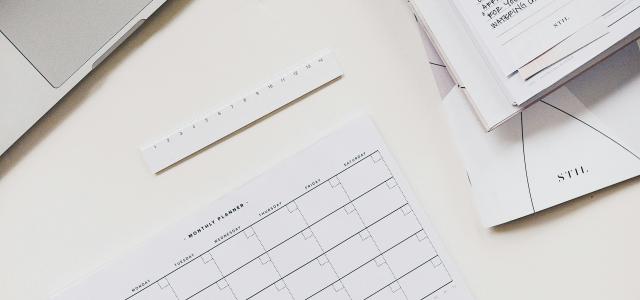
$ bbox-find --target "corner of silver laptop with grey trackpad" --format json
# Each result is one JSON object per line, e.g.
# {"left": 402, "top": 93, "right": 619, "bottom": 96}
{"left": 0, "top": 0, "right": 166, "bottom": 155}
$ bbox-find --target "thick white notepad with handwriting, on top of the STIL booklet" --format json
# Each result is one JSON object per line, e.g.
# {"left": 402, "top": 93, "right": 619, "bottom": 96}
{"left": 411, "top": 0, "right": 640, "bottom": 130}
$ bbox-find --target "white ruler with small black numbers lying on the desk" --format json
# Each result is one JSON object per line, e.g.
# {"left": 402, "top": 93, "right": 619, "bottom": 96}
{"left": 141, "top": 50, "right": 343, "bottom": 173}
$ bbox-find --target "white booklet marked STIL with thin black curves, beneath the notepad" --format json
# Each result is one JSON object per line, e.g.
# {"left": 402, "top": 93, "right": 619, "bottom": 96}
{"left": 418, "top": 21, "right": 640, "bottom": 226}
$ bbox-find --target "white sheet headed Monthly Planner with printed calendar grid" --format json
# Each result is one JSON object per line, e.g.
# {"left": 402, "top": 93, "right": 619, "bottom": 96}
{"left": 54, "top": 118, "right": 472, "bottom": 300}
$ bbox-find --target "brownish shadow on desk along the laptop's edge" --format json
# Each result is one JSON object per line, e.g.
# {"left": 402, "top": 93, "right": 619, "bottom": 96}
{"left": 0, "top": 1, "right": 192, "bottom": 179}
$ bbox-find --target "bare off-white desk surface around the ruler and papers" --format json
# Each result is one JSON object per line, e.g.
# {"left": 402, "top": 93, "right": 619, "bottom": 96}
{"left": 0, "top": 0, "right": 640, "bottom": 300}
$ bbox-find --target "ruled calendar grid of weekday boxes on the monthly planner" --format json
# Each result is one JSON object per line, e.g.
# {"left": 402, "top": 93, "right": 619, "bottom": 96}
{"left": 125, "top": 151, "right": 455, "bottom": 300}
